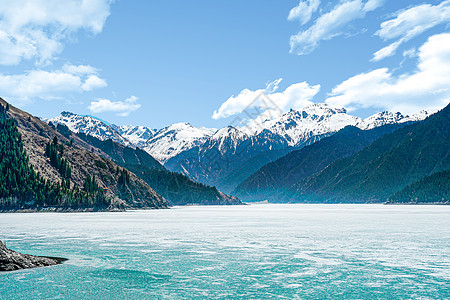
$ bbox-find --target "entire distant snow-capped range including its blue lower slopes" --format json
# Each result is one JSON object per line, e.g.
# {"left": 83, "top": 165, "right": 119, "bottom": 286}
{"left": 47, "top": 104, "right": 430, "bottom": 193}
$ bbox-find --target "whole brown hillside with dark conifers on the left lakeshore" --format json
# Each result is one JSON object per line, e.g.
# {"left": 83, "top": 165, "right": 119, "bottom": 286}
{"left": 0, "top": 98, "right": 168, "bottom": 211}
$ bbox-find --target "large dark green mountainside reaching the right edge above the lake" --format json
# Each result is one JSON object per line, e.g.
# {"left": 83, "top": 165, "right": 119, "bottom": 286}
{"left": 288, "top": 105, "right": 450, "bottom": 202}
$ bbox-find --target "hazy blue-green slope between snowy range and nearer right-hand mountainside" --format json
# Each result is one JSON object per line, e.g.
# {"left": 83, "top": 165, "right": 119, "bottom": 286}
{"left": 233, "top": 123, "right": 406, "bottom": 201}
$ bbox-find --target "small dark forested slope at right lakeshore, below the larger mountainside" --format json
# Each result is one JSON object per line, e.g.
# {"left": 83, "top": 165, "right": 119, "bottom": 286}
{"left": 388, "top": 170, "right": 450, "bottom": 204}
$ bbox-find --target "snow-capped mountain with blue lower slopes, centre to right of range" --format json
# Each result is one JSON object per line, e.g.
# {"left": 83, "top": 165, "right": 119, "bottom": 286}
{"left": 165, "top": 104, "right": 428, "bottom": 192}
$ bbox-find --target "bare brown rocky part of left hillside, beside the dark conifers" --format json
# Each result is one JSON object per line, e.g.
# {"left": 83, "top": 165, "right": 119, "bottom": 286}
{"left": 0, "top": 98, "right": 169, "bottom": 209}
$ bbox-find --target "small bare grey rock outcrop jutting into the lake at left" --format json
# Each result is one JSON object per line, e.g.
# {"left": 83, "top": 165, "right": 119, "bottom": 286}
{"left": 0, "top": 241, "right": 67, "bottom": 271}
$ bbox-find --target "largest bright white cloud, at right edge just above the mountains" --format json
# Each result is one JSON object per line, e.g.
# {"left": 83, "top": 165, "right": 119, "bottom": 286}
{"left": 326, "top": 33, "right": 450, "bottom": 113}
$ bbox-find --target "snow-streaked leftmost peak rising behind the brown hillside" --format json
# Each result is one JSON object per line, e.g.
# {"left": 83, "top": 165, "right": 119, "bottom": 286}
{"left": 45, "top": 111, "right": 131, "bottom": 146}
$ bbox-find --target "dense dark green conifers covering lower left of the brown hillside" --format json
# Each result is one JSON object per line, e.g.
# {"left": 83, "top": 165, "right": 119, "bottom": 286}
{"left": 0, "top": 105, "right": 110, "bottom": 209}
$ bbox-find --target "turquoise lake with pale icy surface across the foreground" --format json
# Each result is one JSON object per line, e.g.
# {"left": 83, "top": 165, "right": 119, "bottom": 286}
{"left": 0, "top": 204, "right": 450, "bottom": 299}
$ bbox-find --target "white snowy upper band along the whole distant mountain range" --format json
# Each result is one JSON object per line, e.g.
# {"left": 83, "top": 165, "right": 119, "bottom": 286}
{"left": 44, "top": 103, "right": 432, "bottom": 163}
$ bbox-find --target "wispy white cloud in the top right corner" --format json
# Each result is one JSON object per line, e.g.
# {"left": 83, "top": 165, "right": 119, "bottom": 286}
{"left": 372, "top": 1, "right": 450, "bottom": 61}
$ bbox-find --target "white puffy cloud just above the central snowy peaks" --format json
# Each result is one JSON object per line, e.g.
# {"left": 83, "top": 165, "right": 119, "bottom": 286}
{"left": 212, "top": 79, "right": 320, "bottom": 119}
